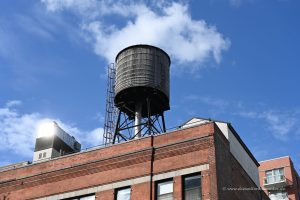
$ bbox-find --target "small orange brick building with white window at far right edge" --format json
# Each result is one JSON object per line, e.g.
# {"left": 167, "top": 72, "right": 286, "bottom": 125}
{"left": 259, "top": 156, "right": 300, "bottom": 200}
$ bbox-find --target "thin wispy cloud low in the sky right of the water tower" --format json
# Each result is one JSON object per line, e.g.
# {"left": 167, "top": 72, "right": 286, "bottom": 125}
{"left": 183, "top": 94, "right": 300, "bottom": 141}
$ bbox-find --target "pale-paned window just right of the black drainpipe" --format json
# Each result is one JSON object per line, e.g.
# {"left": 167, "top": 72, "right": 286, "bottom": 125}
{"left": 156, "top": 180, "right": 173, "bottom": 200}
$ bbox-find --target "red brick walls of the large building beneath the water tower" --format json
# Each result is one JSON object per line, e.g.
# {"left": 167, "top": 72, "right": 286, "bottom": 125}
{"left": 0, "top": 123, "right": 264, "bottom": 200}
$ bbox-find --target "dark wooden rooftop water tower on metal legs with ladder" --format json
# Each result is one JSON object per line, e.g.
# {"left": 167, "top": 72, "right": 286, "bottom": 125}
{"left": 104, "top": 45, "right": 171, "bottom": 144}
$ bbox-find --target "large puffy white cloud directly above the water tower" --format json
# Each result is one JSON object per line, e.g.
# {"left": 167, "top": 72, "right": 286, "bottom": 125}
{"left": 42, "top": 0, "right": 230, "bottom": 69}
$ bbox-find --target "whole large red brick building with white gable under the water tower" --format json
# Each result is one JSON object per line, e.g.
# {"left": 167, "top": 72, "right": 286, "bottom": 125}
{"left": 0, "top": 119, "right": 268, "bottom": 200}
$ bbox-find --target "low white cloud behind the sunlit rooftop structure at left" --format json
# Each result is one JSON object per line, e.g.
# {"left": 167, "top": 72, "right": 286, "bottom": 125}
{"left": 0, "top": 100, "right": 103, "bottom": 159}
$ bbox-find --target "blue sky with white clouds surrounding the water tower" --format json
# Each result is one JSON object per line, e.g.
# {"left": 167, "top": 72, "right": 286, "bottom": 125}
{"left": 0, "top": 0, "right": 300, "bottom": 171}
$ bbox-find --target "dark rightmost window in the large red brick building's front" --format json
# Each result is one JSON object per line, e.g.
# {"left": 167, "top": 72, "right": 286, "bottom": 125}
{"left": 183, "top": 174, "right": 201, "bottom": 200}
